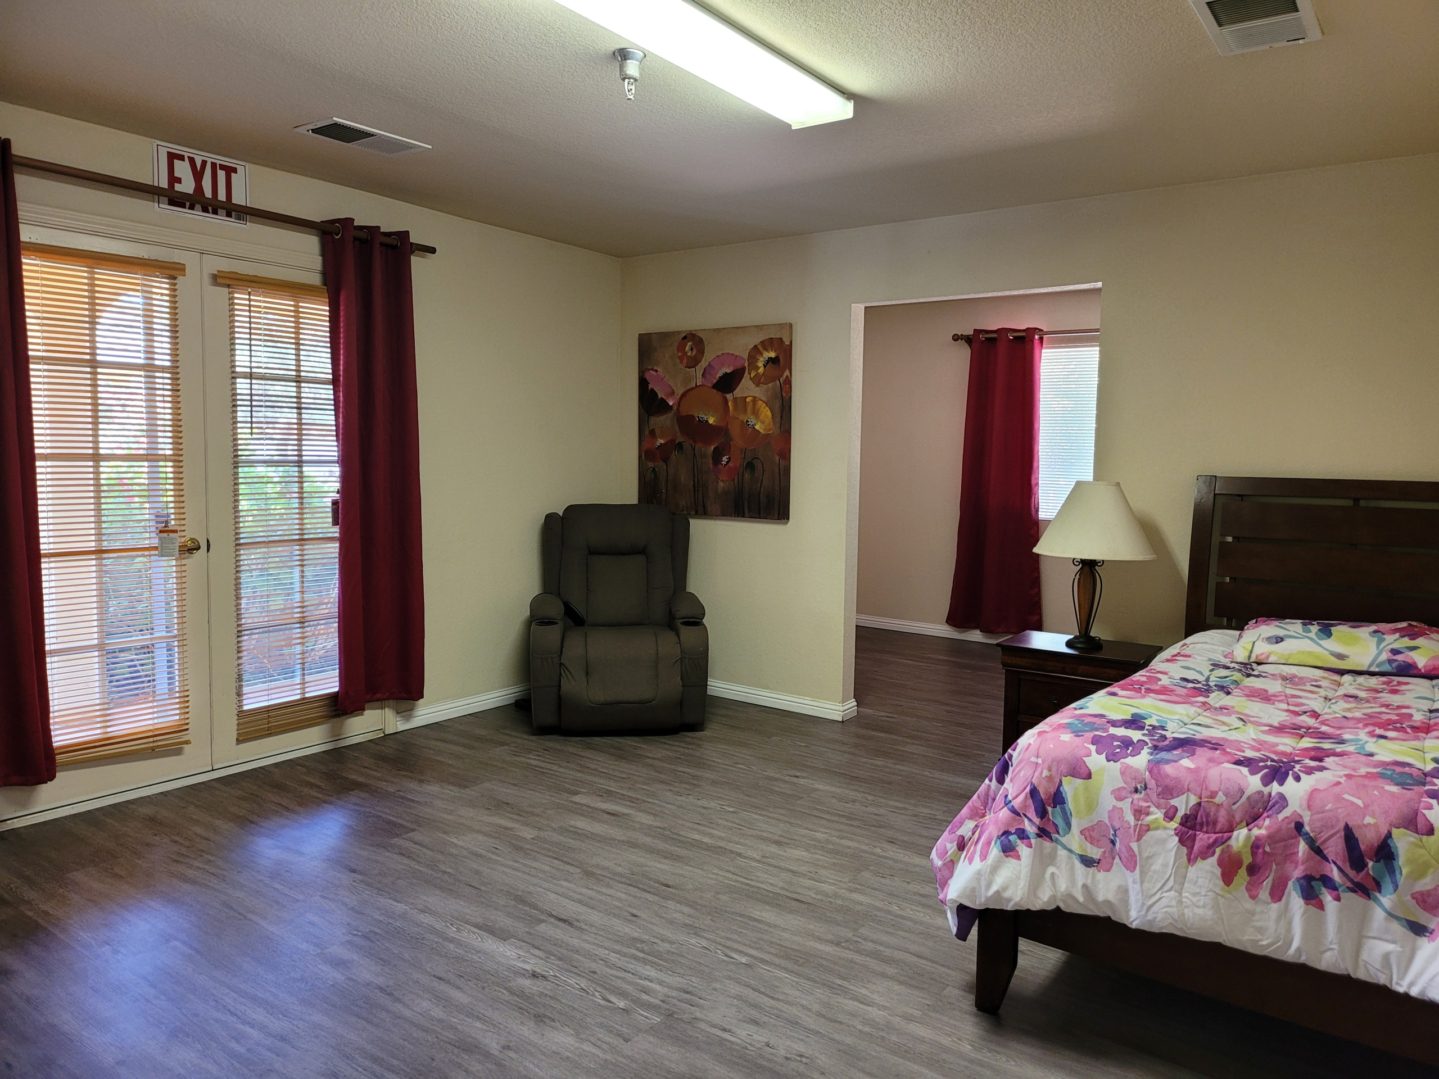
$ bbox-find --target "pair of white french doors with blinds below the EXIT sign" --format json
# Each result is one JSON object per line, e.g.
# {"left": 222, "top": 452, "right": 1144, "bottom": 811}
{"left": 0, "top": 227, "right": 384, "bottom": 819}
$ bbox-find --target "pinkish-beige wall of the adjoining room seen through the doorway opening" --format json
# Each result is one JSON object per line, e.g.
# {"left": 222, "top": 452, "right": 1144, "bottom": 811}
{"left": 856, "top": 289, "right": 1104, "bottom": 633}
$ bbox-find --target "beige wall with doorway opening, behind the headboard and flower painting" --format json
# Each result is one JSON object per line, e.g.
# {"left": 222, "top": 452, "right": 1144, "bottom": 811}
{"left": 620, "top": 155, "right": 1439, "bottom": 701}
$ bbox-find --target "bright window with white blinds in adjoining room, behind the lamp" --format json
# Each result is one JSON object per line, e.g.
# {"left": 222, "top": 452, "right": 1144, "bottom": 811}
{"left": 1039, "top": 337, "right": 1099, "bottom": 521}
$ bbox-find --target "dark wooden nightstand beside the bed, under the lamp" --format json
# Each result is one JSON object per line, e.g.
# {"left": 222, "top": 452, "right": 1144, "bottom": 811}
{"left": 999, "top": 630, "right": 1160, "bottom": 750}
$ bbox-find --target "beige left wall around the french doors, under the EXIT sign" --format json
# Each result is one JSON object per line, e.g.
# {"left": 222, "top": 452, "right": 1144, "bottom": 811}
{"left": 0, "top": 104, "right": 635, "bottom": 817}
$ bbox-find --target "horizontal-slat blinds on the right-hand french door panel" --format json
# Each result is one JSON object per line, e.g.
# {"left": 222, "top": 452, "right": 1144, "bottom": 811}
{"left": 225, "top": 273, "right": 340, "bottom": 741}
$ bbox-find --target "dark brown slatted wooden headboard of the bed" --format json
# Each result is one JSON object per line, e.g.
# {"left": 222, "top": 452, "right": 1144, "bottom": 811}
{"left": 1184, "top": 476, "right": 1439, "bottom": 634}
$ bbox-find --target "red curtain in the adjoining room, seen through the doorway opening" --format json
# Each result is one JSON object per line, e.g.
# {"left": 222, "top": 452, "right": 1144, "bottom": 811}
{"left": 945, "top": 327, "right": 1043, "bottom": 633}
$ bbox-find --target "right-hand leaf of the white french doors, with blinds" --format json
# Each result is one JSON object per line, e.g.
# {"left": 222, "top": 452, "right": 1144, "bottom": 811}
{"left": 203, "top": 256, "right": 383, "bottom": 764}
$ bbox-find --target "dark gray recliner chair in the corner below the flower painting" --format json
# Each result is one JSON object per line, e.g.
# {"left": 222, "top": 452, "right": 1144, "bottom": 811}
{"left": 530, "top": 505, "right": 709, "bottom": 734}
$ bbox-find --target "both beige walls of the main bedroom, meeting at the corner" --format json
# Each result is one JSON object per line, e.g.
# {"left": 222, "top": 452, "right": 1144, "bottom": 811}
{"left": 11, "top": 105, "right": 1439, "bottom": 736}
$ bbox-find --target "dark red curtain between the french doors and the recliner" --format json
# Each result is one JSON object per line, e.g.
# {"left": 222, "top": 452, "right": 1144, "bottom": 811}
{"left": 324, "top": 217, "right": 425, "bottom": 712}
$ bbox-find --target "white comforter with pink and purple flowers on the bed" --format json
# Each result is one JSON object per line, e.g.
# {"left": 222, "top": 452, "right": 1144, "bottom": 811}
{"left": 931, "top": 630, "right": 1439, "bottom": 1001}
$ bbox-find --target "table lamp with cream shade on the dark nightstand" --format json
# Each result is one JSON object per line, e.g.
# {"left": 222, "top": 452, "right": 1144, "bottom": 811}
{"left": 1035, "top": 479, "right": 1154, "bottom": 652}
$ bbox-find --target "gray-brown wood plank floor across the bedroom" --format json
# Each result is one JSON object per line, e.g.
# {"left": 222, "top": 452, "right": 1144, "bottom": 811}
{"left": 0, "top": 629, "right": 1419, "bottom": 1079}
